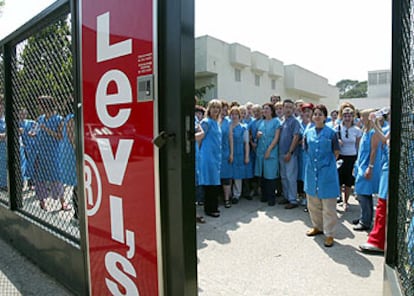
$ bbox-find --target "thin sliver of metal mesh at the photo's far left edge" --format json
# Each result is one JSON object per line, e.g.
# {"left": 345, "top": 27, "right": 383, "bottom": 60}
{"left": 0, "top": 52, "right": 9, "bottom": 205}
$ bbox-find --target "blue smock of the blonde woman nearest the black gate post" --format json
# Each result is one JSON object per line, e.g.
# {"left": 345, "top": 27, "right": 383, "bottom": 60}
{"left": 199, "top": 117, "right": 222, "bottom": 185}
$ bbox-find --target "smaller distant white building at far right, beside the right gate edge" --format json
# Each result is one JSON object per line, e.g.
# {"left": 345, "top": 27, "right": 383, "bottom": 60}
{"left": 340, "top": 70, "right": 391, "bottom": 110}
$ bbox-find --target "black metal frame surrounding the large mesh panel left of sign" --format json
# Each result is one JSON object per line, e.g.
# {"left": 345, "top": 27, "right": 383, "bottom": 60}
{"left": 0, "top": 0, "right": 89, "bottom": 295}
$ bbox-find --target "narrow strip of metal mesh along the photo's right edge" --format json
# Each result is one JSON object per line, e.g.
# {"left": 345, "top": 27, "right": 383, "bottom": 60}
{"left": 396, "top": 0, "right": 414, "bottom": 295}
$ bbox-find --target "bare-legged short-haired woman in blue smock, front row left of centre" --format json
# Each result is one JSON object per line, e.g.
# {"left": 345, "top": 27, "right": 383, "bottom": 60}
{"left": 229, "top": 106, "right": 249, "bottom": 204}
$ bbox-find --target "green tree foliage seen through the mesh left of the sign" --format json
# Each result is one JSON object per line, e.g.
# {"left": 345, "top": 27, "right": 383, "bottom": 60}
{"left": 16, "top": 17, "right": 73, "bottom": 111}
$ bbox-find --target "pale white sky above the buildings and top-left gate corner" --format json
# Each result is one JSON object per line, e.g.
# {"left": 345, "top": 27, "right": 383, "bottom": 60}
{"left": 0, "top": 0, "right": 392, "bottom": 84}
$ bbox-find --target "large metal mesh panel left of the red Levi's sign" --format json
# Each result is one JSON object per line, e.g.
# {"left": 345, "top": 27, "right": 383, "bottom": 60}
{"left": 8, "top": 16, "right": 79, "bottom": 241}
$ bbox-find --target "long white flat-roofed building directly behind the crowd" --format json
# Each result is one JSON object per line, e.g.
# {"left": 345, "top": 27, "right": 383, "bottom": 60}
{"left": 195, "top": 36, "right": 339, "bottom": 110}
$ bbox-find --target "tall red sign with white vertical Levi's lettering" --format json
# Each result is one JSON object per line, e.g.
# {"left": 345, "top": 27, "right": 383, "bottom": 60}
{"left": 81, "top": 0, "right": 160, "bottom": 296}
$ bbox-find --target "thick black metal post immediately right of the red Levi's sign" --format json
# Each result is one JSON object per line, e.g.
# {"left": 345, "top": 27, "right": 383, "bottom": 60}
{"left": 158, "top": 0, "right": 197, "bottom": 296}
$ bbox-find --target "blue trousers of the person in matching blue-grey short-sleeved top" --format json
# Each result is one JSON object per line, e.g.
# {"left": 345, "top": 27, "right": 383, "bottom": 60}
{"left": 279, "top": 154, "right": 298, "bottom": 204}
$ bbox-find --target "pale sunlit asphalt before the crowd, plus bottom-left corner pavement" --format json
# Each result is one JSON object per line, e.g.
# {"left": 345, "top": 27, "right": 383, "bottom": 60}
{"left": 0, "top": 194, "right": 384, "bottom": 296}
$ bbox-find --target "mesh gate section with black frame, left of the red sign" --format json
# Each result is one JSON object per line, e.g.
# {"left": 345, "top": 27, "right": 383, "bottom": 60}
{"left": 0, "top": 1, "right": 88, "bottom": 294}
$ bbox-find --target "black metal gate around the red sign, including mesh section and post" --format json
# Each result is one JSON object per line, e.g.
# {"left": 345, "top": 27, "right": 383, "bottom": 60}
{"left": 0, "top": 0, "right": 197, "bottom": 295}
